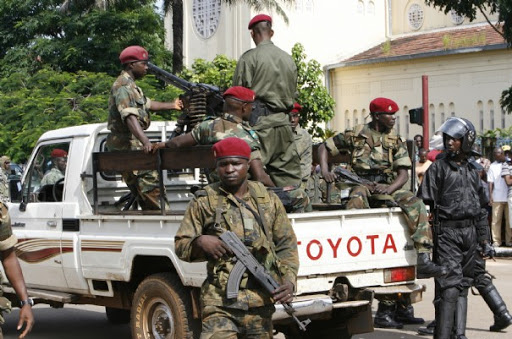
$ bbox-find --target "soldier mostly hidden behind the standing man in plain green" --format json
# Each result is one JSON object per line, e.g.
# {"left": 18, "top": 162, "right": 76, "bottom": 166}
{"left": 290, "top": 102, "right": 314, "bottom": 210}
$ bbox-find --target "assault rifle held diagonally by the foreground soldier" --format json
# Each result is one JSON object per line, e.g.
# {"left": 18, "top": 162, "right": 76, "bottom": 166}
{"left": 220, "top": 231, "right": 311, "bottom": 331}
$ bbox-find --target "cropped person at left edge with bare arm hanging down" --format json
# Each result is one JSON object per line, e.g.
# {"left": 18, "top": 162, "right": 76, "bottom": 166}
{"left": 0, "top": 158, "right": 34, "bottom": 339}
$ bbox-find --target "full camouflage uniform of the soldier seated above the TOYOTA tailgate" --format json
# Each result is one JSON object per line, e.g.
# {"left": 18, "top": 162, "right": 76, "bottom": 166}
{"left": 325, "top": 124, "right": 432, "bottom": 253}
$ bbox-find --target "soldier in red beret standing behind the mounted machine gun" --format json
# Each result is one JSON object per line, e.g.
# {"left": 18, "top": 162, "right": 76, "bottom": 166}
{"left": 106, "top": 46, "right": 183, "bottom": 210}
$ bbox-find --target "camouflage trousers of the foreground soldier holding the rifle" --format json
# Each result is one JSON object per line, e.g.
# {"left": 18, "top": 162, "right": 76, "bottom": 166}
{"left": 200, "top": 305, "right": 275, "bottom": 339}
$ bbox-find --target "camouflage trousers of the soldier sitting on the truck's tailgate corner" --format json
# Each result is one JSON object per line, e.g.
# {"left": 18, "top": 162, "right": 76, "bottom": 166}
{"left": 320, "top": 183, "right": 433, "bottom": 253}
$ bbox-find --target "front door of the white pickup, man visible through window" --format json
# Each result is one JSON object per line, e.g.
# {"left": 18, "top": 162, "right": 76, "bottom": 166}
{"left": 9, "top": 141, "right": 72, "bottom": 288}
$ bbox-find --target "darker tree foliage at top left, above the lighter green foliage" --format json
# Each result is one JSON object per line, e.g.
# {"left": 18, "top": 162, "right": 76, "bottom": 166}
{"left": 0, "top": 0, "right": 171, "bottom": 76}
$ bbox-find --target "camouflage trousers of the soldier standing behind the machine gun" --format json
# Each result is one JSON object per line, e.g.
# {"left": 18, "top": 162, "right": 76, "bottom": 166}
{"left": 122, "top": 171, "right": 169, "bottom": 210}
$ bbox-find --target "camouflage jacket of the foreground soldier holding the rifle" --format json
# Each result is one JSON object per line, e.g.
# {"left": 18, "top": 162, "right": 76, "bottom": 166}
{"left": 174, "top": 181, "right": 299, "bottom": 310}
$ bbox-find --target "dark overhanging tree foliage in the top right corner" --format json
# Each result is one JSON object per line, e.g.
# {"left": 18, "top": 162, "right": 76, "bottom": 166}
{"left": 426, "top": 0, "right": 512, "bottom": 114}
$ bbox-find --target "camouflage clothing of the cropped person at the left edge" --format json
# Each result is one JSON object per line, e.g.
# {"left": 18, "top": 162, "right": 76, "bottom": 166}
{"left": 0, "top": 170, "right": 18, "bottom": 326}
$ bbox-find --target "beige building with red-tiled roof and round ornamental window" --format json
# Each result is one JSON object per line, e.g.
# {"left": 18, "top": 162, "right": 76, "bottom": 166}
{"left": 166, "top": 0, "right": 512, "bottom": 139}
